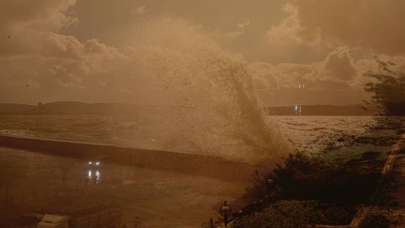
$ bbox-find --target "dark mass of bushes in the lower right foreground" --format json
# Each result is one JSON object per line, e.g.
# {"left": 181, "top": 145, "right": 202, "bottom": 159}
{"left": 229, "top": 153, "right": 382, "bottom": 228}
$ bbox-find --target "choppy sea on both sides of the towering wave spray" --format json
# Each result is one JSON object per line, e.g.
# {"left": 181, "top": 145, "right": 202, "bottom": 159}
{"left": 0, "top": 115, "right": 405, "bottom": 153}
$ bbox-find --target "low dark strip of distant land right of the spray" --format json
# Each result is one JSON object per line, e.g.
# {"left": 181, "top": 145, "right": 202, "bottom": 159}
{"left": 266, "top": 105, "right": 378, "bottom": 116}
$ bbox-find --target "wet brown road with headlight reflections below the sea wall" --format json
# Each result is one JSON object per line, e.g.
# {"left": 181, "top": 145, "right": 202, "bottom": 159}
{"left": 0, "top": 144, "right": 251, "bottom": 228}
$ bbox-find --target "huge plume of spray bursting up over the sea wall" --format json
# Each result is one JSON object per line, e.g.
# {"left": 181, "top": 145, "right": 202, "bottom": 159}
{"left": 118, "top": 20, "right": 286, "bottom": 161}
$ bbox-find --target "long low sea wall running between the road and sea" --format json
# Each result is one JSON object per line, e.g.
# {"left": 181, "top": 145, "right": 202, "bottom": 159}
{"left": 0, "top": 135, "right": 254, "bottom": 181}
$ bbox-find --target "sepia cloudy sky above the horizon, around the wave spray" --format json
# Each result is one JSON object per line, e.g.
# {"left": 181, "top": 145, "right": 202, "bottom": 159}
{"left": 0, "top": 0, "right": 405, "bottom": 105}
